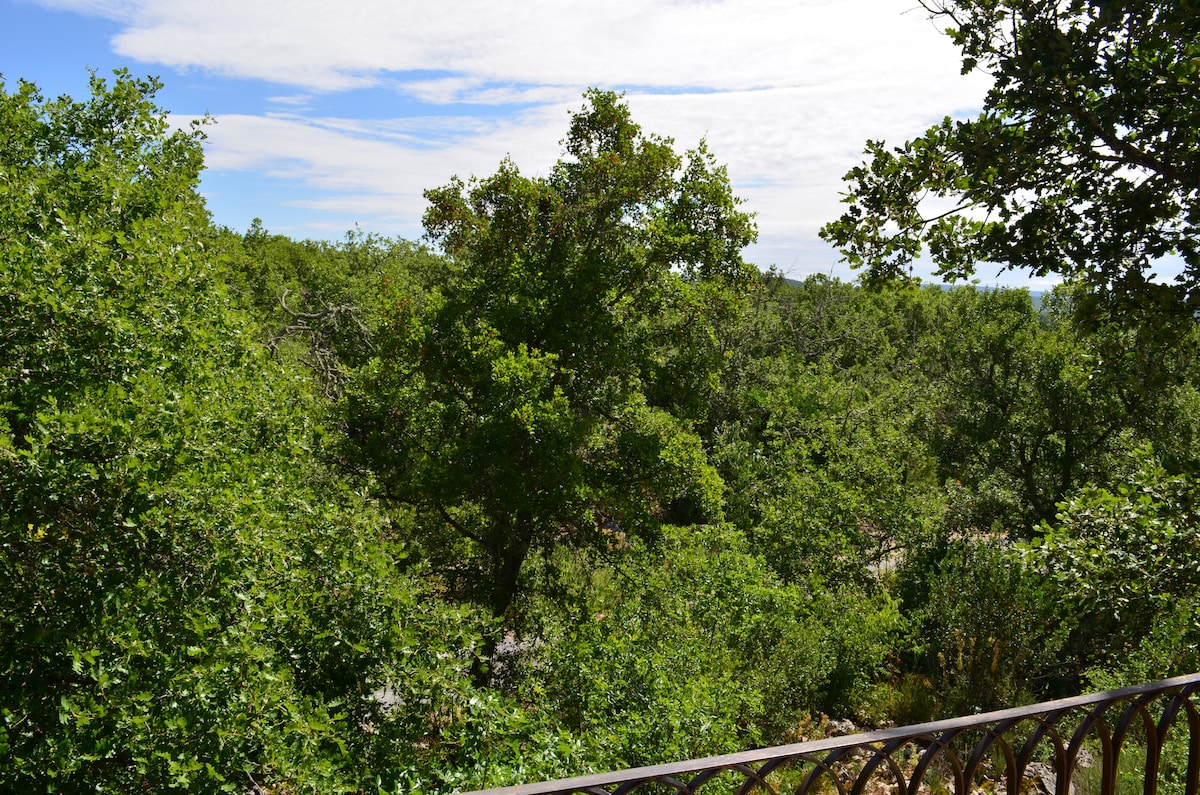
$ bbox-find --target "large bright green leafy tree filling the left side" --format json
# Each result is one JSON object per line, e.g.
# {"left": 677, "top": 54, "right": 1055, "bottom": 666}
{"left": 0, "top": 73, "right": 496, "bottom": 791}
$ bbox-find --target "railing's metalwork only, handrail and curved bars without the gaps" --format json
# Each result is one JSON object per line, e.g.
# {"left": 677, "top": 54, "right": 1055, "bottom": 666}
{"left": 460, "top": 674, "right": 1200, "bottom": 795}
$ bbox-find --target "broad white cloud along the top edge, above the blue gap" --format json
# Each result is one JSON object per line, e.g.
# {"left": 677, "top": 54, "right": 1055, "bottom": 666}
{"left": 54, "top": 0, "right": 974, "bottom": 97}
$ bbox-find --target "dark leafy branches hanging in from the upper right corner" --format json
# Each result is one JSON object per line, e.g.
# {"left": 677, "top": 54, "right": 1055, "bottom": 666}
{"left": 822, "top": 0, "right": 1200, "bottom": 312}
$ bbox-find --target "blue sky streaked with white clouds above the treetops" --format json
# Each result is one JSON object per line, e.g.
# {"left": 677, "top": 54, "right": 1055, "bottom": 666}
{"left": 0, "top": 0, "right": 1041, "bottom": 283}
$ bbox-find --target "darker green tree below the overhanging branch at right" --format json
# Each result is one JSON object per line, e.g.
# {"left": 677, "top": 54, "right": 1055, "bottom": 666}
{"left": 922, "top": 289, "right": 1156, "bottom": 537}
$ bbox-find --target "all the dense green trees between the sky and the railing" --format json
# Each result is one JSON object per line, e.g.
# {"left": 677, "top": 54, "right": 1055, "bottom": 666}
{"left": 0, "top": 1, "right": 1200, "bottom": 793}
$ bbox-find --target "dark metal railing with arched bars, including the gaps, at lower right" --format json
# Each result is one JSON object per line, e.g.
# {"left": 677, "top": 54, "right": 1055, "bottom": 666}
{"left": 460, "top": 674, "right": 1200, "bottom": 795}
